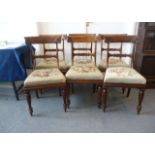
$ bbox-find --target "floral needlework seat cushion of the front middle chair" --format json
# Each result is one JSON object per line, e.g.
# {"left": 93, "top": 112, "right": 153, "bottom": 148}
{"left": 66, "top": 66, "right": 104, "bottom": 80}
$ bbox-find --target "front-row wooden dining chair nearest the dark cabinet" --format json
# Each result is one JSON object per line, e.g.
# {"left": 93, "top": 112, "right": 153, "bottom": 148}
{"left": 100, "top": 35, "right": 146, "bottom": 114}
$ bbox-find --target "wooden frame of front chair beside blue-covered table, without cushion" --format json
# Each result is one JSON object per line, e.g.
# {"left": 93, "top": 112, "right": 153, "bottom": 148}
{"left": 24, "top": 35, "right": 69, "bottom": 116}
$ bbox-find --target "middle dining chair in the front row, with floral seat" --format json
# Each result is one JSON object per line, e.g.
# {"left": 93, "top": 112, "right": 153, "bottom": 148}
{"left": 66, "top": 34, "right": 103, "bottom": 109}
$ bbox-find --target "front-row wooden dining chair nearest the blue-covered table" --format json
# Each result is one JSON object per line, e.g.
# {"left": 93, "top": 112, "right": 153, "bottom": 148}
{"left": 24, "top": 35, "right": 69, "bottom": 116}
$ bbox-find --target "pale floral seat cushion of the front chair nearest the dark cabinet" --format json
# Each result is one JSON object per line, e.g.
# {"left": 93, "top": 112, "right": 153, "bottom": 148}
{"left": 104, "top": 67, "right": 146, "bottom": 85}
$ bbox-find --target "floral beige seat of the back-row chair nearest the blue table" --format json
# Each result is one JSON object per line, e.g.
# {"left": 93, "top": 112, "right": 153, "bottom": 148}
{"left": 36, "top": 58, "right": 69, "bottom": 70}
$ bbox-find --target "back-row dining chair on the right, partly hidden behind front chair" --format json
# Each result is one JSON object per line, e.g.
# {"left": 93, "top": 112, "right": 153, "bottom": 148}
{"left": 98, "top": 34, "right": 134, "bottom": 97}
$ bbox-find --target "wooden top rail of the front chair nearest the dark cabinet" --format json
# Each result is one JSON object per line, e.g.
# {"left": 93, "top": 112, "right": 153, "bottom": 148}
{"left": 104, "top": 35, "right": 138, "bottom": 43}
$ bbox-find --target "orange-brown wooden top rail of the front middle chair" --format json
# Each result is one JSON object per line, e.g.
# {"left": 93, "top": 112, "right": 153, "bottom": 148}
{"left": 68, "top": 35, "right": 97, "bottom": 43}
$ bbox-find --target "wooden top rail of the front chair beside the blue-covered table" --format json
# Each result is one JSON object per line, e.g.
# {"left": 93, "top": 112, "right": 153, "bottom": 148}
{"left": 25, "top": 35, "right": 61, "bottom": 44}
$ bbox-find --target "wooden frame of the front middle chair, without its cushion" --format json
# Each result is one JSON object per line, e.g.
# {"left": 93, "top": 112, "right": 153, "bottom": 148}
{"left": 66, "top": 34, "right": 103, "bottom": 106}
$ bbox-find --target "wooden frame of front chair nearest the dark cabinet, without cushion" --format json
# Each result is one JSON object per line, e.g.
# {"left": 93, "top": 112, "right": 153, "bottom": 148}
{"left": 102, "top": 35, "right": 145, "bottom": 114}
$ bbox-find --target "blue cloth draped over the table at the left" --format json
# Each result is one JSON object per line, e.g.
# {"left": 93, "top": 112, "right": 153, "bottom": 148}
{"left": 0, "top": 44, "right": 30, "bottom": 81}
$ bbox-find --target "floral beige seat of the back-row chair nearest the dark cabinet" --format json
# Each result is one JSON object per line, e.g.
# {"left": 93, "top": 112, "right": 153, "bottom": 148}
{"left": 98, "top": 58, "right": 130, "bottom": 71}
